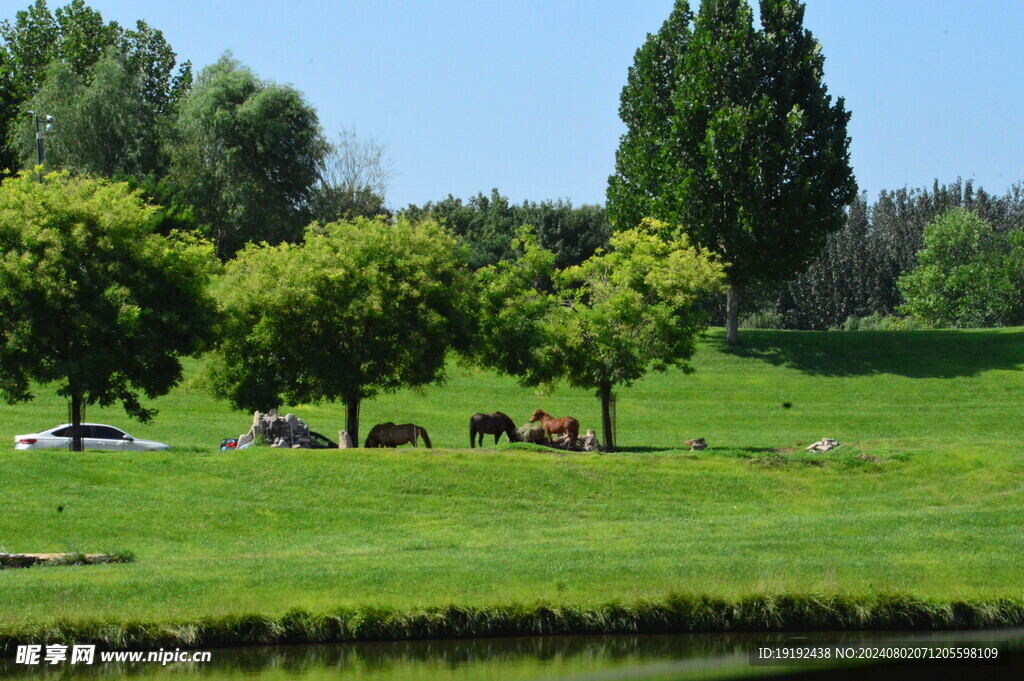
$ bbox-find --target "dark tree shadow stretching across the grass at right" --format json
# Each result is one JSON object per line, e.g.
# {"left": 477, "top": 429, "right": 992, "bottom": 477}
{"left": 724, "top": 329, "right": 1024, "bottom": 378}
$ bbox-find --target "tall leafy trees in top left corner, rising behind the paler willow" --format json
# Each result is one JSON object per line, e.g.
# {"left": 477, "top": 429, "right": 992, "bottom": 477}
{"left": 0, "top": 0, "right": 191, "bottom": 175}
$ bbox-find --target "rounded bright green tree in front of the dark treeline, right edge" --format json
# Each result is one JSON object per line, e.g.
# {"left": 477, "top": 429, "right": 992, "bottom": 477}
{"left": 899, "top": 208, "right": 1024, "bottom": 328}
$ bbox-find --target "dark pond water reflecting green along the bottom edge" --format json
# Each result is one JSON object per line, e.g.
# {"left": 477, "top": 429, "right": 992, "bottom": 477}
{"left": 0, "top": 630, "right": 1024, "bottom": 681}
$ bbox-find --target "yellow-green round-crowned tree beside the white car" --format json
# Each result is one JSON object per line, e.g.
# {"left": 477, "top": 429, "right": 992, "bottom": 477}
{"left": 0, "top": 172, "right": 216, "bottom": 450}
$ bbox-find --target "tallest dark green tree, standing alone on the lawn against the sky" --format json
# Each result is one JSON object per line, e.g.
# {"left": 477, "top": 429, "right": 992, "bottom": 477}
{"left": 608, "top": 0, "right": 856, "bottom": 344}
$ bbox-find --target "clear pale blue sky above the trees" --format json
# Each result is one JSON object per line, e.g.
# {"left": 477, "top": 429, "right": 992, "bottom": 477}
{"left": 0, "top": 0, "right": 1024, "bottom": 207}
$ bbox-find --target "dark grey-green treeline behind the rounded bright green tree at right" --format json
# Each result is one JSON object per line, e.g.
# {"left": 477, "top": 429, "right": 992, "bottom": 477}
{"left": 770, "top": 179, "right": 1024, "bottom": 330}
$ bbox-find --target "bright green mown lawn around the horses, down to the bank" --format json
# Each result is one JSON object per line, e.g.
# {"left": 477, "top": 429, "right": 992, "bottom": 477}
{"left": 0, "top": 330, "right": 1024, "bottom": 625}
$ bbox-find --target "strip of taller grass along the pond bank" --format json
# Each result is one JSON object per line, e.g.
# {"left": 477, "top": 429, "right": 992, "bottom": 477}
{"left": 0, "top": 595, "right": 1024, "bottom": 657}
